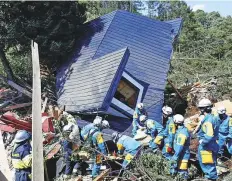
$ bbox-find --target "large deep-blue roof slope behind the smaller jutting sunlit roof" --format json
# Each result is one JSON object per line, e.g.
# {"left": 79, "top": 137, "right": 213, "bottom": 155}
{"left": 94, "top": 11, "right": 173, "bottom": 120}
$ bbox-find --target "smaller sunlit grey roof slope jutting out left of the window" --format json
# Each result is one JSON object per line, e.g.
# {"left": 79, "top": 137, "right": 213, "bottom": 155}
{"left": 58, "top": 48, "right": 129, "bottom": 111}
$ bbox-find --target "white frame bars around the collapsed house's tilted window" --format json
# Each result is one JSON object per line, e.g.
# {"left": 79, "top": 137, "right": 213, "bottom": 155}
{"left": 111, "top": 72, "right": 144, "bottom": 115}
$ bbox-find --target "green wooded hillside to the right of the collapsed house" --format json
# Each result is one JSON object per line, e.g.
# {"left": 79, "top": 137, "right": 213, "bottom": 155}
{"left": 148, "top": 0, "right": 232, "bottom": 98}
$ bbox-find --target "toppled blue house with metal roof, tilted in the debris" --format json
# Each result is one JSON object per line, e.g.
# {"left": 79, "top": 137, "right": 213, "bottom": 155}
{"left": 56, "top": 10, "right": 182, "bottom": 131}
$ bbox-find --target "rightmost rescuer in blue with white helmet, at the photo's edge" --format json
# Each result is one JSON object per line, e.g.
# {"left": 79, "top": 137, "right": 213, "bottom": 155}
{"left": 216, "top": 107, "right": 232, "bottom": 155}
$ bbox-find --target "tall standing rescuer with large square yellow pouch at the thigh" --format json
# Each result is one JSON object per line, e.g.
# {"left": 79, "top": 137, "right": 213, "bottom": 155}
{"left": 198, "top": 99, "right": 219, "bottom": 180}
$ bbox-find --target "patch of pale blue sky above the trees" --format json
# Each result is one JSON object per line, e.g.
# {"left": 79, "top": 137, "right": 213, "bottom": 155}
{"left": 185, "top": 0, "right": 232, "bottom": 16}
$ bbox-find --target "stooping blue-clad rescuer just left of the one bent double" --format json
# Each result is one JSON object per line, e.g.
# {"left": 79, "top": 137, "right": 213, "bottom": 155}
{"left": 88, "top": 128, "right": 107, "bottom": 178}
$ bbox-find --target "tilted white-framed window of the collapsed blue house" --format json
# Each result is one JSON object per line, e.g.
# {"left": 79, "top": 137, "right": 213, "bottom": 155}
{"left": 112, "top": 72, "right": 143, "bottom": 114}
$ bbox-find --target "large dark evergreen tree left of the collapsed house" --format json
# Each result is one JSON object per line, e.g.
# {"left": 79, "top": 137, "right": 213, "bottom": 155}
{"left": 0, "top": 2, "right": 86, "bottom": 79}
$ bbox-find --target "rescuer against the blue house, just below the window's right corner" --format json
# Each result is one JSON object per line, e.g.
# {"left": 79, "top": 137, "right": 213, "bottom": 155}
{"left": 132, "top": 103, "right": 147, "bottom": 136}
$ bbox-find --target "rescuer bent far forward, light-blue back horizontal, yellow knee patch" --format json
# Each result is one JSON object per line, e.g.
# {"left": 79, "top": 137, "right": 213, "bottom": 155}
{"left": 112, "top": 132, "right": 141, "bottom": 168}
